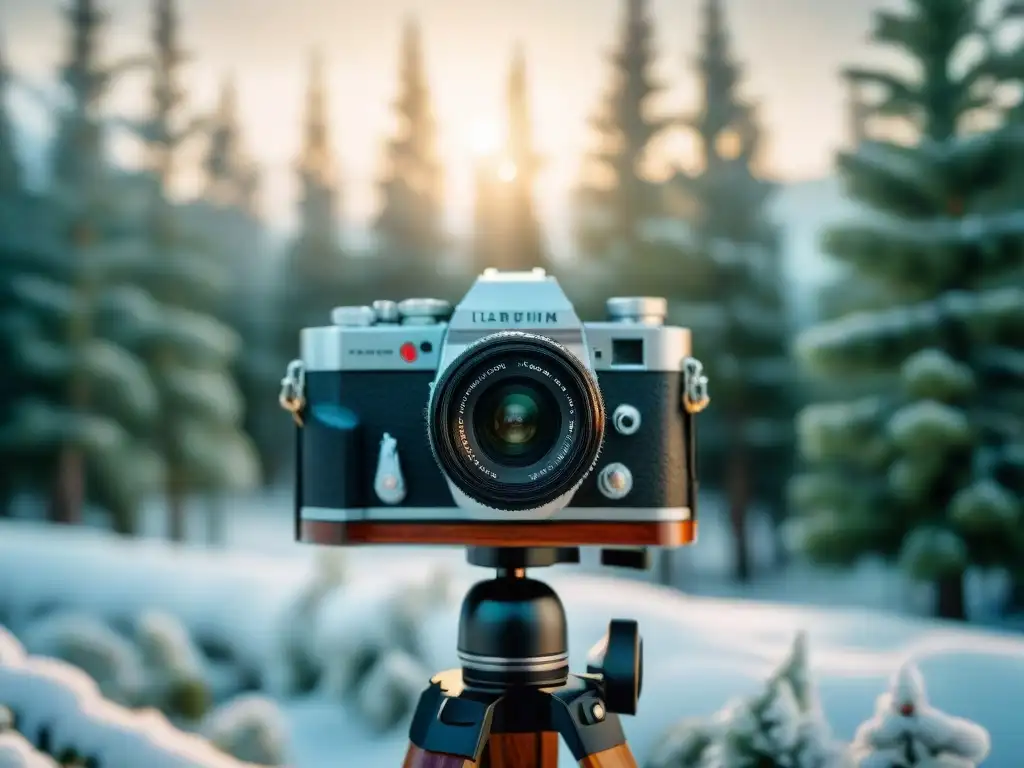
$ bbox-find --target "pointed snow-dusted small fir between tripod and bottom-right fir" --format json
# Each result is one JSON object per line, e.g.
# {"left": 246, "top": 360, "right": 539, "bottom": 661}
{"left": 648, "top": 633, "right": 850, "bottom": 768}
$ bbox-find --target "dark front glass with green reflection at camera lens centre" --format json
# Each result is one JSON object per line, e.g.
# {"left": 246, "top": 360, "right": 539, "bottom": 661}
{"left": 473, "top": 379, "right": 562, "bottom": 466}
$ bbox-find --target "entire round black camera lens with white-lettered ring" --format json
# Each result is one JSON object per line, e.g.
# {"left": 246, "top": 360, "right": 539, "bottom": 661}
{"left": 427, "top": 331, "right": 604, "bottom": 511}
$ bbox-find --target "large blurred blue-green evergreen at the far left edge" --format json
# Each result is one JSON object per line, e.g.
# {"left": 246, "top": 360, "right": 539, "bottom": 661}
{"left": 0, "top": 0, "right": 159, "bottom": 534}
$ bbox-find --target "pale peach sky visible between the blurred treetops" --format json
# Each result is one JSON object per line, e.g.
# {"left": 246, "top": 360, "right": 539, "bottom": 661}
{"left": 0, "top": 0, "right": 901, "bottom": 246}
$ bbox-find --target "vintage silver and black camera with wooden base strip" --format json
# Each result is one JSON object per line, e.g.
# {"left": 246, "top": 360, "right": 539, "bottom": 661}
{"left": 281, "top": 269, "right": 709, "bottom": 548}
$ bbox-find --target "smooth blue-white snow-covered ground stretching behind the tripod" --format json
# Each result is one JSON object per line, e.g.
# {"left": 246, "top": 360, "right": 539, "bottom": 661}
{"left": 0, "top": 521, "right": 1024, "bottom": 768}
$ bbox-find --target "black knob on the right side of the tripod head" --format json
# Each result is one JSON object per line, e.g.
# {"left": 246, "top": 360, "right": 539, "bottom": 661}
{"left": 587, "top": 618, "right": 643, "bottom": 715}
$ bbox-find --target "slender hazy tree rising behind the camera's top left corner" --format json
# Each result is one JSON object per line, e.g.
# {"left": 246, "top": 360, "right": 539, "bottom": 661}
{"left": 275, "top": 54, "right": 350, "bottom": 360}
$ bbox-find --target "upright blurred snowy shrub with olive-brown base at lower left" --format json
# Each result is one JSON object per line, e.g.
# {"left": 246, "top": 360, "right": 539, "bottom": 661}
{"left": 135, "top": 611, "right": 210, "bottom": 720}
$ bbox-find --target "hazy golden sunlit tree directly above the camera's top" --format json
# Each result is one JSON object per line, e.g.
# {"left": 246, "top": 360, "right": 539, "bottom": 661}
{"left": 473, "top": 48, "right": 550, "bottom": 272}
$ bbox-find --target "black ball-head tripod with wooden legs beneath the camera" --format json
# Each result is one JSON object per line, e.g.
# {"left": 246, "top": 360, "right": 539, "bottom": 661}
{"left": 402, "top": 547, "right": 643, "bottom": 768}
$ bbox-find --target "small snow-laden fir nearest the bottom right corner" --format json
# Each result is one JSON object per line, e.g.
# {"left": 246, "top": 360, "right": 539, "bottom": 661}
{"left": 850, "top": 663, "right": 990, "bottom": 768}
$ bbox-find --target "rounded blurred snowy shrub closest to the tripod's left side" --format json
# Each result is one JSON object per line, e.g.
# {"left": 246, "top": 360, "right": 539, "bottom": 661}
{"left": 355, "top": 650, "right": 430, "bottom": 733}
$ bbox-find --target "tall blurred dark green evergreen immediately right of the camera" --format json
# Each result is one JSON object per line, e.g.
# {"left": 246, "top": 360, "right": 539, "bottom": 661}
{"left": 675, "top": 0, "right": 797, "bottom": 581}
